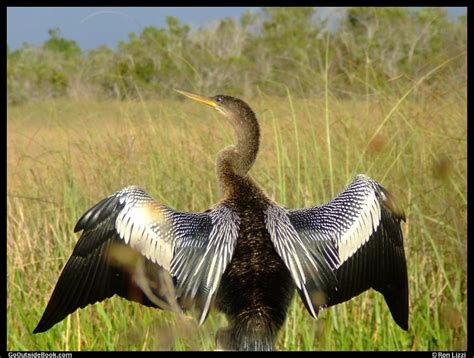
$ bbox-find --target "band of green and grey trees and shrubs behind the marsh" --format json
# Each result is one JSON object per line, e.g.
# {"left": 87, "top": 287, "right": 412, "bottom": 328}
{"left": 7, "top": 8, "right": 467, "bottom": 104}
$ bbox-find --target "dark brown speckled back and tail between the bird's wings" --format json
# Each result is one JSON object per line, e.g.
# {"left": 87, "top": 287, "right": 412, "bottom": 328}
{"left": 217, "top": 178, "right": 295, "bottom": 350}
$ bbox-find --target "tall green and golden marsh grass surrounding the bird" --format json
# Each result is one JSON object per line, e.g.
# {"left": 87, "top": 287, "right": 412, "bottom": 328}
{"left": 7, "top": 74, "right": 467, "bottom": 350}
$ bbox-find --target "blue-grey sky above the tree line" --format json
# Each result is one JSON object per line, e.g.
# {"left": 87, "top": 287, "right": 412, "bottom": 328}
{"left": 7, "top": 7, "right": 467, "bottom": 50}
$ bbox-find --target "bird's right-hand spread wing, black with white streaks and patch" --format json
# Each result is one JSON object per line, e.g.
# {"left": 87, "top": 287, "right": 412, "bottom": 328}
{"left": 266, "top": 175, "right": 408, "bottom": 330}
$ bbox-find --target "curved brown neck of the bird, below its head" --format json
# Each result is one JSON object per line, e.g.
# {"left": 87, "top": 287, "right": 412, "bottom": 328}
{"left": 216, "top": 107, "right": 260, "bottom": 196}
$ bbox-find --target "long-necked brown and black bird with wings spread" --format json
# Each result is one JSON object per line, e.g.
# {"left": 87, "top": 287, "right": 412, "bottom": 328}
{"left": 34, "top": 90, "right": 409, "bottom": 351}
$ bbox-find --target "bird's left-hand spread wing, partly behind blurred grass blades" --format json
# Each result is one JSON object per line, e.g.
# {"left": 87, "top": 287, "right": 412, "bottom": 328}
{"left": 34, "top": 186, "right": 239, "bottom": 333}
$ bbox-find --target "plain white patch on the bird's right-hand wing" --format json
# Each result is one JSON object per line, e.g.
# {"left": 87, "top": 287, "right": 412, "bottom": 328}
{"left": 338, "top": 189, "right": 381, "bottom": 266}
